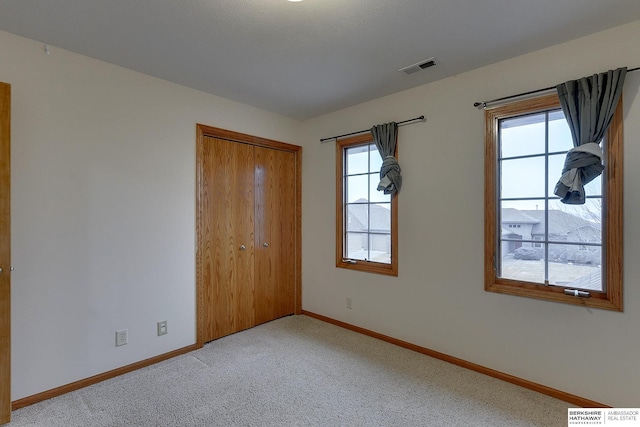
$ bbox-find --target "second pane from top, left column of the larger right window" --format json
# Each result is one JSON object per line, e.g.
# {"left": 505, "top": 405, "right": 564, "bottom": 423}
{"left": 500, "top": 157, "right": 545, "bottom": 198}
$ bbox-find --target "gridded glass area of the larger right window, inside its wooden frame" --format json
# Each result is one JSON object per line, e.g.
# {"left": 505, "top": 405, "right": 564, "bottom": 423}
{"left": 498, "top": 108, "right": 604, "bottom": 291}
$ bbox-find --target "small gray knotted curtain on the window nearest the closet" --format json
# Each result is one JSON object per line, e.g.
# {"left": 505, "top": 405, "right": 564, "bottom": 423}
{"left": 371, "top": 122, "right": 402, "bottom": 194}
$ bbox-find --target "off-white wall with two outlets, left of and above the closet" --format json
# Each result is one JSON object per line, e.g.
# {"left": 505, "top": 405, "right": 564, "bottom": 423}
{"left": 0, "top": 32, "right": 300, "bottom": 400}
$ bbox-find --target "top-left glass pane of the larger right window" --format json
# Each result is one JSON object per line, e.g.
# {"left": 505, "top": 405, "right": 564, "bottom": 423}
{"left": 500, "top": 113, "right": 545, "bottom": 157}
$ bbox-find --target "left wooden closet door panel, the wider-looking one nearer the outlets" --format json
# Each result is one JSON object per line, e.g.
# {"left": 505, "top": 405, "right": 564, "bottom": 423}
{"left": 200, "top": 137, "right": 255, "bottom": 342}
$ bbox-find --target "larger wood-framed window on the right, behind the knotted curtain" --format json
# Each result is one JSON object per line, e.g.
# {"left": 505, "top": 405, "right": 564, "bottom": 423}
{"left": 485, "top": 95, "right": 623, "bottom": 311}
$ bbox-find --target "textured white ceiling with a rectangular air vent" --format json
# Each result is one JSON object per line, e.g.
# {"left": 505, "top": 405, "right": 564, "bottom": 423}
{"left": 0, "top": 0, "right": 640, "bottom": 119}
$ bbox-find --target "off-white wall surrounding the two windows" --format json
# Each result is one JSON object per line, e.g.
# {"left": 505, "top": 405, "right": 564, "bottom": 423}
{"left": 302, "top": 21, "right": 640, "bottom": 407}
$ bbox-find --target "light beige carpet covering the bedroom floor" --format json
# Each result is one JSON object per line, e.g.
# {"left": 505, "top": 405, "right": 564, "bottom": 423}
{"left": 9, "top": 316, "right": 571, "bottom": 427}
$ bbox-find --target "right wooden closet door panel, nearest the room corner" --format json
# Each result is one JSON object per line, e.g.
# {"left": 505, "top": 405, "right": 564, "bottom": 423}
{"left": 254, "top": 147, "right": 297, "bottom": 324}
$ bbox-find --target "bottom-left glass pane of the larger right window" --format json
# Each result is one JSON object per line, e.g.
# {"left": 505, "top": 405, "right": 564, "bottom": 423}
{"left": 500, "top": 241, "right": 544, "bottom": 284}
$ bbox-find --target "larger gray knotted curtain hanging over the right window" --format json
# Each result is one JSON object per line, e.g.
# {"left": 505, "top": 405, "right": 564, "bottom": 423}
{"left": 554, "top": 67, "right": 627, "bottom": 205}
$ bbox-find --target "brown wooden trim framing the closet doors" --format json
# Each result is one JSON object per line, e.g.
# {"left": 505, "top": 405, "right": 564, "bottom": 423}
{"left": 196, "top": 124, "right": 302, "bottom": 348}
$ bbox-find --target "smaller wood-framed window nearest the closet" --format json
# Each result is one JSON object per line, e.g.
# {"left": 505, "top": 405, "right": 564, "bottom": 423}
{"left": 336, "top": 133, "right": 398, "bottom": 276}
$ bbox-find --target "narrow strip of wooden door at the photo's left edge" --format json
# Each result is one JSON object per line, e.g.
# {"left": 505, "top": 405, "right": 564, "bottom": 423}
{"left": 0, "top": 83, "right": 11, "bottom": 424}
